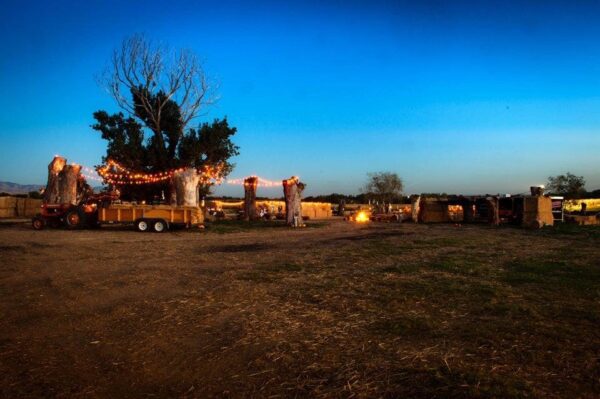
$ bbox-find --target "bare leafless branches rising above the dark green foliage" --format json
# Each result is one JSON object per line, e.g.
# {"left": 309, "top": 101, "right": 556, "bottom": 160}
{"left": 101, "top": 34, "right": 216, "bottom": 132}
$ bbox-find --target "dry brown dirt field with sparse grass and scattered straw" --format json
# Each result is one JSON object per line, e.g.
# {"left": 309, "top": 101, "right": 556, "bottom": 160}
{"left": 0, "top": 221, "right": 600, "bottom": 398}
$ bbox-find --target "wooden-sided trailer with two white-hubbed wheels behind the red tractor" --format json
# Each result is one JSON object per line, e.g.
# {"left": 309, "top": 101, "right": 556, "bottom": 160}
{"left": 98, "top": 204, "right": 204, "bottom": 233}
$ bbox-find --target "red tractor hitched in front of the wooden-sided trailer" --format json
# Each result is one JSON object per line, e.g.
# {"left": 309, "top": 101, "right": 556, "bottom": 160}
{"left": 31, "top": 193, "right": 118, "bottom": 230}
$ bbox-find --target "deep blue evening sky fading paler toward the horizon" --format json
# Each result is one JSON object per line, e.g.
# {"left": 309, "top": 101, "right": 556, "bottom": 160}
{"left": 0, "top": 0, "right": 600, "bottom": 195}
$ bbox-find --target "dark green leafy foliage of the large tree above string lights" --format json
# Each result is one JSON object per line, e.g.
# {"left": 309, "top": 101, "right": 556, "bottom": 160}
{"left": 92, "top": 97, "right": 239, "bottom": 200}
